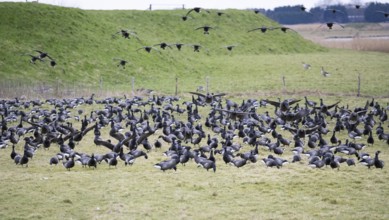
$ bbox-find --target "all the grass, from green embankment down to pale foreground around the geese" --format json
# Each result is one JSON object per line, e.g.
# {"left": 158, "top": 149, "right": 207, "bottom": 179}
{"left": 0, "top": 3, "right": 389, "bottom": 219}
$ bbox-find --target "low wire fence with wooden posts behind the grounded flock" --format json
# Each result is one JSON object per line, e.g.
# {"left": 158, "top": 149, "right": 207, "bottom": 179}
{"left": 0, "top": 74, "right": 366, "bottom": 100}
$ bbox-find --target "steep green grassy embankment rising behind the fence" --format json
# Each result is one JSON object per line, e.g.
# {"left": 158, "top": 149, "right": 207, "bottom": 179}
{"left": 0, "top": 3, "right": 326, "bottom": 92}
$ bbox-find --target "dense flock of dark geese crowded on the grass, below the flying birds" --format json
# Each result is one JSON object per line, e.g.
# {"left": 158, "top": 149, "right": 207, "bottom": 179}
{"left": 0, "top": 92, "right": 389, "bottom": 172}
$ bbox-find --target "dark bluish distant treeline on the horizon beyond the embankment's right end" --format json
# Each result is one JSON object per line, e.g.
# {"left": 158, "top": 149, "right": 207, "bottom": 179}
{"left": 257, "top": 3, "right": 389, "bottom": 24}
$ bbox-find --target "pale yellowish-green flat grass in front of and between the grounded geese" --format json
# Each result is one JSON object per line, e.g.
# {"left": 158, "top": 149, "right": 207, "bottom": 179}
{"left": 0, "top": 98, "right": 389, "bottom": 219}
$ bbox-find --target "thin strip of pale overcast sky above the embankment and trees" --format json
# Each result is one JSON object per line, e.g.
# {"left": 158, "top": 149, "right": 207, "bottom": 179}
{"left": 0, "top": 0, "right": 389, "bottom": 10}
